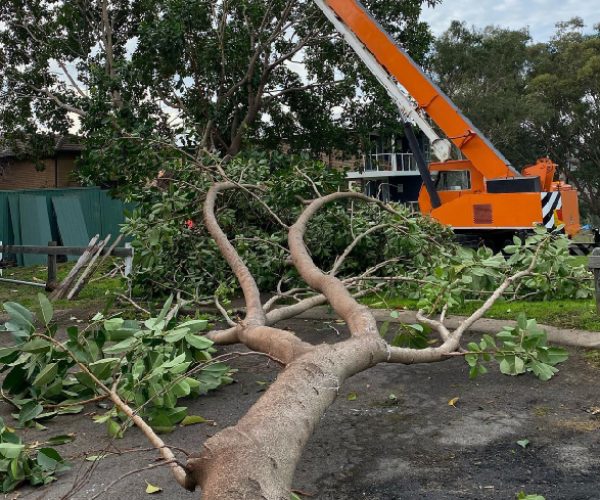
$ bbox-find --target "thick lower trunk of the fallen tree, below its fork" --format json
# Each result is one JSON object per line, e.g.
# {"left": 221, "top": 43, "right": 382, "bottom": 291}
{"left": 187, "top": 336, "right": 387, "bottom": 500}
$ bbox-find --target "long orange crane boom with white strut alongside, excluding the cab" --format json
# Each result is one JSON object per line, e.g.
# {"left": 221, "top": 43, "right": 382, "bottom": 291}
{"left": 315, "top": 0, "right": 521, "bottom": 179}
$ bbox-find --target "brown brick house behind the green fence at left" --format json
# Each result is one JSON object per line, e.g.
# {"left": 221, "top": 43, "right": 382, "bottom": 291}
{"left": 0, "top": 136, "right": 83, "bottom": 191}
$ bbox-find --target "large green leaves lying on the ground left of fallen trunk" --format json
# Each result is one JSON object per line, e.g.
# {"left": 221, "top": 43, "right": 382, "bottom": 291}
{"left": 0, "top": 294, "right": 231, "bottom": 437}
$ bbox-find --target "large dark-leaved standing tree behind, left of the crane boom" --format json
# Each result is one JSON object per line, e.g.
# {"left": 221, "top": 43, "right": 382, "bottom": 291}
{"left": 0, "top": 0, "right": 438, "bottom": 186}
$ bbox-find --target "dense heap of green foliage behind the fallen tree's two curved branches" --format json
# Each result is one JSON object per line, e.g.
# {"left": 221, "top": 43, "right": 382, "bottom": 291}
{"left": 125, "top": 152, "right": 455, "bottom": 297}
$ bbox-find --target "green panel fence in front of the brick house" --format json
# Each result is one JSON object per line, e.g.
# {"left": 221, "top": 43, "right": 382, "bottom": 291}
{"left": 0, "top": 187, "right": 134, "bottom": 266}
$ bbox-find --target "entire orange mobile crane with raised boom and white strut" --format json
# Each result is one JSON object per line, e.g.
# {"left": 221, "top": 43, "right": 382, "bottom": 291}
{"left": 314, "top": 0, "right": 580, "bottom": 245}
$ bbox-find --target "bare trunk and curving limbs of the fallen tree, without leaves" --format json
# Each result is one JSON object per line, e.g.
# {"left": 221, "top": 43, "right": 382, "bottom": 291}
{"left": 176, "top": 182, "right": 564, "bottom": 500}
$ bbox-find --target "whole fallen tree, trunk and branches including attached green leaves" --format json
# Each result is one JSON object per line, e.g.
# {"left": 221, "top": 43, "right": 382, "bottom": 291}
{"left": 4, "top": 178, "right": 566, "bottom": 500}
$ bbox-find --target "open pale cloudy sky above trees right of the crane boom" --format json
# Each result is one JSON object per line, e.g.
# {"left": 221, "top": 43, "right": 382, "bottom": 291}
{"left": 422, "top": 0, "right": 600, "bottom": 42}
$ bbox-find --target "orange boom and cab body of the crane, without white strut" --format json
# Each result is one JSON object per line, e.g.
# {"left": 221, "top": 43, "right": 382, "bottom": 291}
{"left": 324, "top": 0, "right": 580, "bottom": 240}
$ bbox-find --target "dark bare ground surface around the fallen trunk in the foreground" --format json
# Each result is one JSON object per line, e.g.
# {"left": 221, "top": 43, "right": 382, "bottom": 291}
{"left": 3, "top": 320, "right": 600, "bottom": 500}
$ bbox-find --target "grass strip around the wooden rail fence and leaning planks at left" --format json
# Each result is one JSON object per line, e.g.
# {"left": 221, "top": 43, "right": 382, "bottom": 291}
{"left": 0, "top": 262, "right": 125, "bottom": 309}
